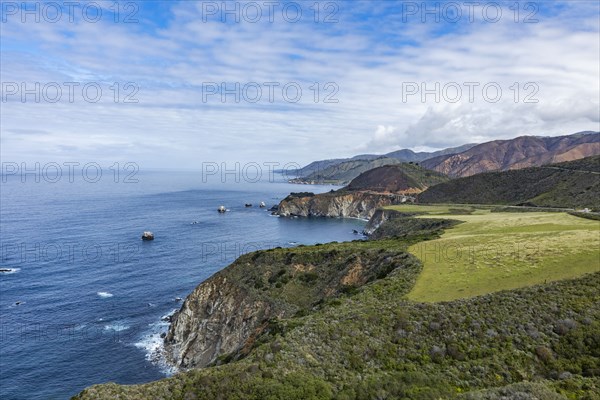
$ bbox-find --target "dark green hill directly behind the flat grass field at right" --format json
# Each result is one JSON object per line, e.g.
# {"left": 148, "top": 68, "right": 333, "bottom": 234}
{"left": 418, "top": 156, "right": 600, "bottom": 210}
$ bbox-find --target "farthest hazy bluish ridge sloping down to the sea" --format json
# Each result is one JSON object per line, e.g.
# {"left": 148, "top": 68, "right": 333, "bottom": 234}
{"left": 296, "top": 143, "right": 476, "bottom": 178}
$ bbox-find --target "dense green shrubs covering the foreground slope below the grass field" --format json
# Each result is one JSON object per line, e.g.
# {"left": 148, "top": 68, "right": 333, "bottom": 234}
{"left": 76, "top": 267, "right": 600, "bottom": 400}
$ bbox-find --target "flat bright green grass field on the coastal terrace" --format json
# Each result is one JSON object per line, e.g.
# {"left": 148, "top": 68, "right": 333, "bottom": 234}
{"left": 390, "top": 205, "right": 600, "bottom": 302}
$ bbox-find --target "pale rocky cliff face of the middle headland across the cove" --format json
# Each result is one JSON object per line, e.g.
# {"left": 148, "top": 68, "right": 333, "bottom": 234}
{"left": 277, "top": 192, "right": 402, "bottom": 219}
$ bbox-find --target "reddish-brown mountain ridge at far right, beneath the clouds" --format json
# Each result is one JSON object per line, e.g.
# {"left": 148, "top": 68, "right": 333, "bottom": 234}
{"left": 422, "top": 132, "right": 600, "bottom": 177}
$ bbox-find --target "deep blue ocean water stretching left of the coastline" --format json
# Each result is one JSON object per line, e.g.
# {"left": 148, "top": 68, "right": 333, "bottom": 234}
{"left": 0, "top": 172, "right": 364, "bottom": 400}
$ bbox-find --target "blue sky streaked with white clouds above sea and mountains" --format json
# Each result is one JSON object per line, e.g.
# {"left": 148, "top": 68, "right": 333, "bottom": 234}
{"left": 0, "top": 0, "right": 600, "bottom": 169}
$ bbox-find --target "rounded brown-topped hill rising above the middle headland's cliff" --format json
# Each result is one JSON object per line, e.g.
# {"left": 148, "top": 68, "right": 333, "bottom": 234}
{"left": 345, "top": 163, "right": 448, "bottom": 194}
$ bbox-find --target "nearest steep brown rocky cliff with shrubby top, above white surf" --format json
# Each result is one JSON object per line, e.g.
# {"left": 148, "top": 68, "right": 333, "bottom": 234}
{"left": 165, "top": 248, "right": 407, "bottom": 369}
